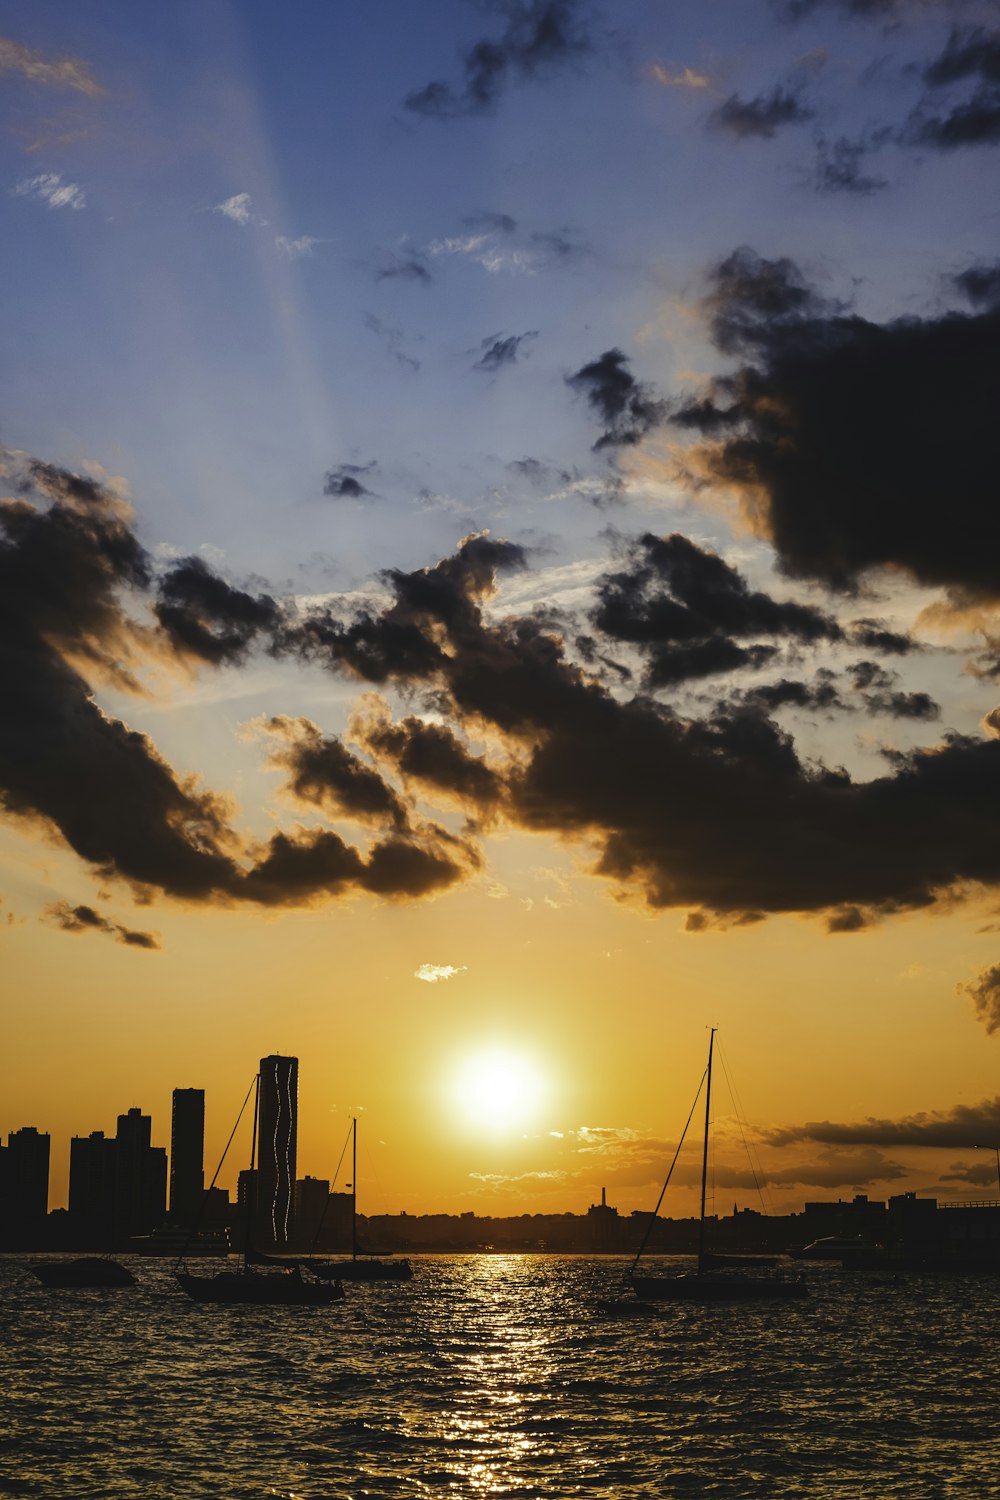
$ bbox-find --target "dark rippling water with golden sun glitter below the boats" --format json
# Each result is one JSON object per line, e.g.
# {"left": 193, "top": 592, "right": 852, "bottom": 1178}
{"left": 0, "top": 1254, "right": 1000, "bottom": 1500}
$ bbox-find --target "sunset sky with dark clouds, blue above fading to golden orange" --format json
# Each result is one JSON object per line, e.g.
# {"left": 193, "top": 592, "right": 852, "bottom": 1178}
{"left": 0, "top": 0, "right": 1000, "bottom": 1215}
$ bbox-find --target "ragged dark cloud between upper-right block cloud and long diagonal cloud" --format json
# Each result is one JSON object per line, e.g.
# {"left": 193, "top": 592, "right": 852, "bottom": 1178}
{"left": 592, "top": 533, "right": 841, "bottom": 687}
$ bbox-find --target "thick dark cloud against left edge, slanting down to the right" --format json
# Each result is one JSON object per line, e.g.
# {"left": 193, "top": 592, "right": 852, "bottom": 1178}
{"left": 0, "top": 458, "right": 248, "bottom": 899}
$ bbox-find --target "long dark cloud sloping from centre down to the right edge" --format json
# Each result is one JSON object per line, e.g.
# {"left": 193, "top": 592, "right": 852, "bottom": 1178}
{"left": 283, "top": 539, "right": 1000, "bottom": 926}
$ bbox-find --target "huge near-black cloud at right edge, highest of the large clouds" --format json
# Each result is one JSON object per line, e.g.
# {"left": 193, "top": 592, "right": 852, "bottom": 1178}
{"left": 673, "top": 249, "right": 1000, "bottom": 599}
